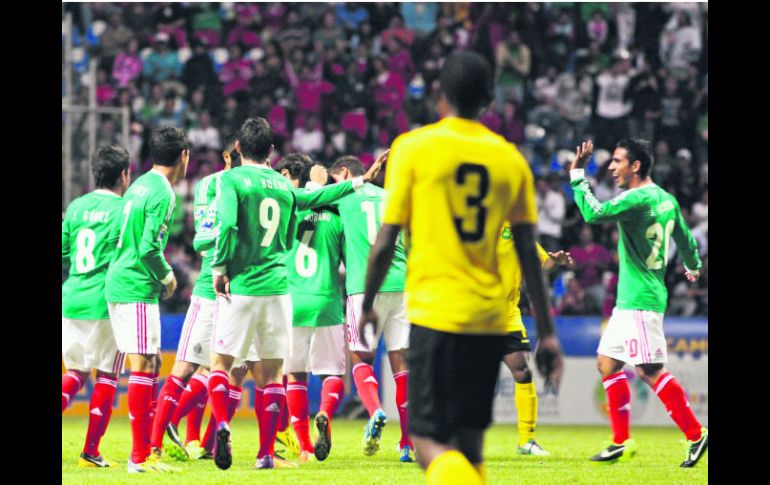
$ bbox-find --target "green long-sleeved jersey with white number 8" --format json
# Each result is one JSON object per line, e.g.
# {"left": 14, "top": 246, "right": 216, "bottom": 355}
{"left": 61, "top": 189, "right": 123, "bottom": 320}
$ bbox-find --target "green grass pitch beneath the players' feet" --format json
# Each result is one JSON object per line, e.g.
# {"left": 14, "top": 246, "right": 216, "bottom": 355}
{"left": 62, "top": 416, "right": 708, "bottom": 485}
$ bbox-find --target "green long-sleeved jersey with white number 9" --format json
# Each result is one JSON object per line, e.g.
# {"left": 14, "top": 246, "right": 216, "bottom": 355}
{"left": 211, "top": 165, "right": 297, "bottom": 296}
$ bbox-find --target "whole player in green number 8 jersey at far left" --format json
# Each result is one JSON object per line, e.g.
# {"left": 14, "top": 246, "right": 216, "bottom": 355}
{"left": 61, "top": 145, "right": 130, "bottom": 467}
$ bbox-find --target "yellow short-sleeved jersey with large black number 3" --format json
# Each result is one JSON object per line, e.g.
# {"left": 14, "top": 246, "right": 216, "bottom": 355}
{"left": 383, "top": 117, "right": 537, "bottom": 335}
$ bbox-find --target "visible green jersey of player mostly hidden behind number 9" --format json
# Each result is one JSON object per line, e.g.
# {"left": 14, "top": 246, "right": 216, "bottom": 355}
{"left": 193, "top": 172, "right": 224, "bottom": 300}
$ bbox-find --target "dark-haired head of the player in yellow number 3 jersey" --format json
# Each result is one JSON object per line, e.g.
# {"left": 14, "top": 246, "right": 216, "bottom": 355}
{"left": 439, "top": 51, "right": 492, "bottom": 119}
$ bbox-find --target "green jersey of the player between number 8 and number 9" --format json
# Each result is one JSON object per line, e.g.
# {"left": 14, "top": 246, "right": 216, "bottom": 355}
{"left": 105, "top": 170, "right": 176, "bottom": 303}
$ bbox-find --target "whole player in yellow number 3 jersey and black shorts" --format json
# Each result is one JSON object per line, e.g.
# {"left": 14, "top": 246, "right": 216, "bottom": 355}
{"left": 359, "top": 51, "right": 561, "bottom": 485}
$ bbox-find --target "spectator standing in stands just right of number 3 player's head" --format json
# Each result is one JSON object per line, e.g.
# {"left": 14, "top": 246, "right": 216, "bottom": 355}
{"left": 495, "top": 30, "right": 532, "bottom": 109}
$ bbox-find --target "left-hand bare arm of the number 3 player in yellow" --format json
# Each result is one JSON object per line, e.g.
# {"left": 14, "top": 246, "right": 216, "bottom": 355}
{"left": 358, "top": 224, "right": 401, "bottom": 345}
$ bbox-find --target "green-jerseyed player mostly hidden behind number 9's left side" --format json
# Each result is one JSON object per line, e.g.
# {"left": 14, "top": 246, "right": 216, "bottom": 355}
{"left": 150, "top": 133, "right": 245, "bottom": 461}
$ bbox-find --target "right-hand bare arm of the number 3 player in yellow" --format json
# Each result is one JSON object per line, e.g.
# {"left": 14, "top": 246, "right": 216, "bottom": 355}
{"left": 511, "top": 224, "right": 564, "bottom": 391}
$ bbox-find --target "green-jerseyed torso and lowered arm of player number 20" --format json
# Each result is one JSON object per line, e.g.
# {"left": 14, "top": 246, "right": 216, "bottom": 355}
{"left": 612, "top": 184, "right": 699, "bottom": 313}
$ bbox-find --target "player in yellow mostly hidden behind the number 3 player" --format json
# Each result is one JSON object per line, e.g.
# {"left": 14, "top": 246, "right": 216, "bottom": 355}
{"left": 497, "top": 224, "right": 572, "bottom": 456}
